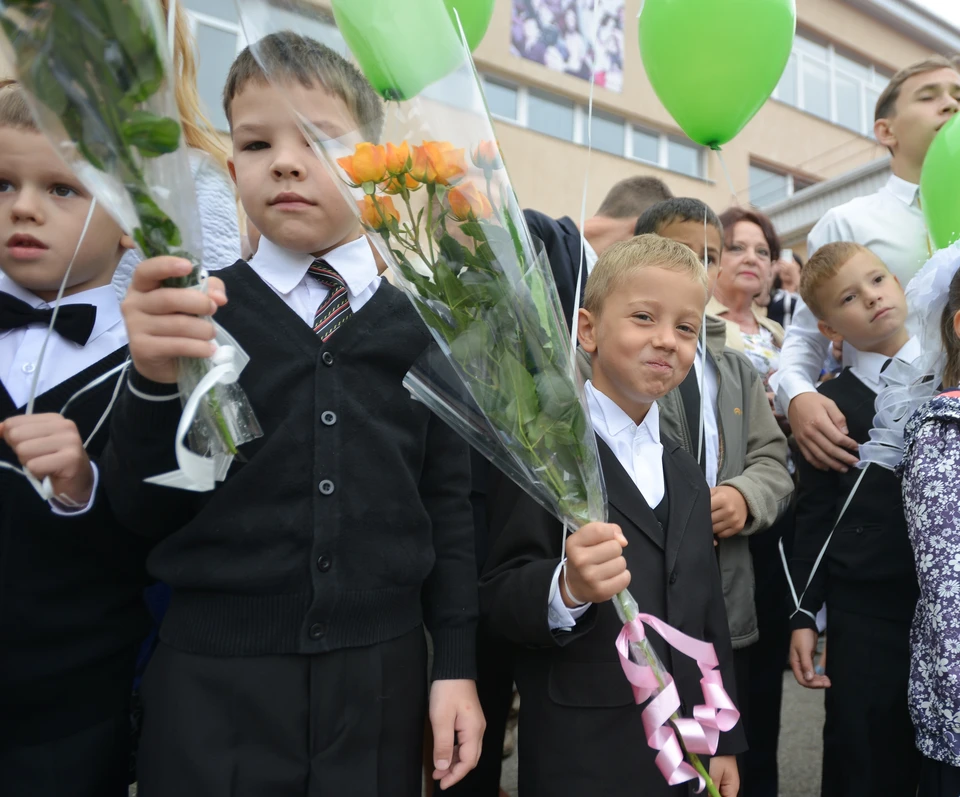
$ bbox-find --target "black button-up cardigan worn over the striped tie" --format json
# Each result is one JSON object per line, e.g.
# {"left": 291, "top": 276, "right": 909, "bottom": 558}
{"left": 104, "top": 261, "right": 477, "bottom": 678}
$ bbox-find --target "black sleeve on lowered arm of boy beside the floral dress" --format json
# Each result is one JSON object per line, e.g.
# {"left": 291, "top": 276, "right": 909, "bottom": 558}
{"left": 790, "top": 448, "right": 841, "bottom": 630}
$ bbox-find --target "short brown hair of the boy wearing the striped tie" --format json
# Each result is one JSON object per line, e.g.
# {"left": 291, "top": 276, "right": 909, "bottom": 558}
{"left": 223, "top": 30, "right": 383, "bottom": 141}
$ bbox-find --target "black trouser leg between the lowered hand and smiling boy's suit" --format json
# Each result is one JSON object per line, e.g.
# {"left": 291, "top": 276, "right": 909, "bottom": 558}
{"left": 444, "top": 622, "right": 515, "bottom": 797}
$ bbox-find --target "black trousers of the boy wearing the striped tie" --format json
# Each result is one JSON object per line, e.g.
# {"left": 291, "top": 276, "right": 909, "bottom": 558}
{"left": 138, "top": 627, "right": 427, "bottom": 797}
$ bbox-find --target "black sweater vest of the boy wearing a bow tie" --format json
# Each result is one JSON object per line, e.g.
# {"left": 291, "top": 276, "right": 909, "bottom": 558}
{"left": 0, "top": 348, "right": 149, "bottom": 743}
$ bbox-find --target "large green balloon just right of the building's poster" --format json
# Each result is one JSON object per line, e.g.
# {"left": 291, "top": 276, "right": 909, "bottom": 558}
{"left": 639, "top": 0, "right": 797, "bottom": 148}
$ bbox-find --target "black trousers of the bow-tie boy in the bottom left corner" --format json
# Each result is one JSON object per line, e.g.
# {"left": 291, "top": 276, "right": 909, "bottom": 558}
{"left": 0, "top": 704, "right": 130, "bottom": 797}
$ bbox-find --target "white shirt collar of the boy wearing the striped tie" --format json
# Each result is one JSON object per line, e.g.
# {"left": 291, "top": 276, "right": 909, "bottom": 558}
{"left": 250, "top": 236, "right": 380, "bottom": 327}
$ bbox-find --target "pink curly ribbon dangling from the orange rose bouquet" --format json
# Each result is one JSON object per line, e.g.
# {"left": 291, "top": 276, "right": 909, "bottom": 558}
{"left": 617, "top": 614, "right": 740, "bottom": 794}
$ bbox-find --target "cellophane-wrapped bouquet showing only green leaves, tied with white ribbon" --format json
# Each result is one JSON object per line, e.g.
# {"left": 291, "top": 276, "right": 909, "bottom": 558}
{"left": 0, "top": 0, "right": 261, "bottom": 470}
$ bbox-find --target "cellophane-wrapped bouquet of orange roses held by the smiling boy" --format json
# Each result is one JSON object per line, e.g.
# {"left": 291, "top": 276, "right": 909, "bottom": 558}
{"left": 237, "top": 0, "right": 736, "bottom": 785}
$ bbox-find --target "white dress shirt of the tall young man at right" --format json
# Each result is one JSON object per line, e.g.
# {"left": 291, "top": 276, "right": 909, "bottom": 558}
{"left": 770, "top": 175, "right": 932, "bottom": 413}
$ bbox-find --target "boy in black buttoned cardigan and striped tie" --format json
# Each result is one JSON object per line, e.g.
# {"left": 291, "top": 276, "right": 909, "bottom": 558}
{"left": 104, "top": 32, "right": 483, "bottom": 797}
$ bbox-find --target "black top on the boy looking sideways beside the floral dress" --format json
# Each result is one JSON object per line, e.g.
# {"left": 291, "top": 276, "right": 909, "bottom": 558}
{"left": 790, "top": 369, "right": 919, "bottom": 629}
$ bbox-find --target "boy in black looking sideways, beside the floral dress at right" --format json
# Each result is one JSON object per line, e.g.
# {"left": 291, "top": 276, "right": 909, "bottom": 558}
{"left": 790, "top": 243, "right": 920, "bottom": 797}
